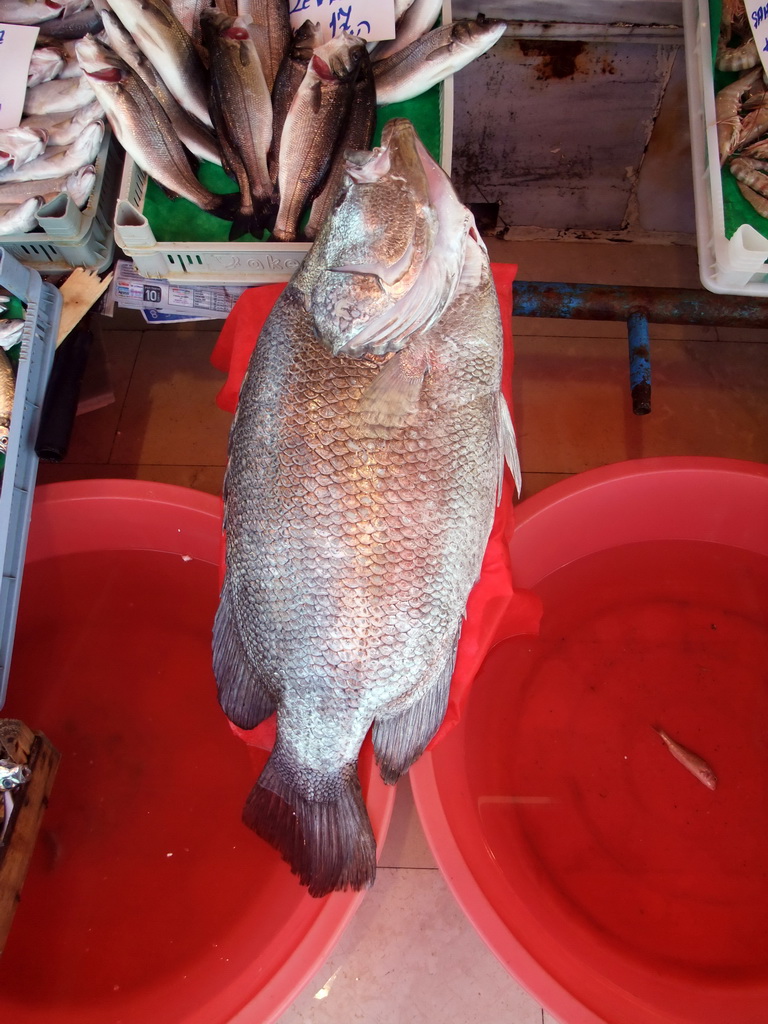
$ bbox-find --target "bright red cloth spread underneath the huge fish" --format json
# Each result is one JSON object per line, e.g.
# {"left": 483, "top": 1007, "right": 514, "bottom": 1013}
{"left": 211, "top": 263, "right": 541, "bottom": 749}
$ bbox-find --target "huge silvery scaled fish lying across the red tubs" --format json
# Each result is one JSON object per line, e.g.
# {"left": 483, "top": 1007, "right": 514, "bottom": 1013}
{"left": 213, "top": 120, "right": 515, "bottom": 896}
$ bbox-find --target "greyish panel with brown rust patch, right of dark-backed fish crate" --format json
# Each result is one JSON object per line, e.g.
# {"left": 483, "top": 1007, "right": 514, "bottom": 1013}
{"left": 453, "top": 37, "right": 677, "bottom": 230}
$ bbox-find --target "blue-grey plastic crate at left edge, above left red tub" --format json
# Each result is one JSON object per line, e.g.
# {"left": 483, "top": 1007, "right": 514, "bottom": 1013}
{"left": 0, "top": 249, "right": 61, "bottom": 708}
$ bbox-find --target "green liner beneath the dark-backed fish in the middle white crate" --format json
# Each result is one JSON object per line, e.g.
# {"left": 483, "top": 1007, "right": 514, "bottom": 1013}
{"left": 143, "top": 85, "right": 442, "bottom": 245}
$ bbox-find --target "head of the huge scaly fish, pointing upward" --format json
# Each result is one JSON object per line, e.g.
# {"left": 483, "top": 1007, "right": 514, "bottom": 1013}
{"left": 295, "top": 119, "right": 437, "bottom": 354}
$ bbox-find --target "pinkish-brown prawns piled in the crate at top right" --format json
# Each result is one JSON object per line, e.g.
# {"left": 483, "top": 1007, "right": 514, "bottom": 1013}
{"left": 715, "top": 0, "right": 768, "bottom": 217}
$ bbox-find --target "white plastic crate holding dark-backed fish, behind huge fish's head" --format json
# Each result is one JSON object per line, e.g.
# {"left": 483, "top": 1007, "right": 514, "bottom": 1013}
{"left": 115, "top": 0, "right": 454, "bottom": 285}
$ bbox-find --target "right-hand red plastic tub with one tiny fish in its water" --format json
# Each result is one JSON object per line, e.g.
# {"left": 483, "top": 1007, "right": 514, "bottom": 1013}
{"left": 412, "top": 458, "right": 768, "bottom": 1024}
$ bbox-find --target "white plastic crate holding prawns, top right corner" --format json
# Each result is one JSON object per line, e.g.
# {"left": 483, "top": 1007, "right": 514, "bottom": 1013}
{"left": 683, "top": 0, "right": 768, "bottom": 297}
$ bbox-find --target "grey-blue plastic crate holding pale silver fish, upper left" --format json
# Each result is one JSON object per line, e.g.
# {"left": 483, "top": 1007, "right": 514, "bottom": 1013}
{"left": 0, "top": 127, "right": 123, "bottom": 273}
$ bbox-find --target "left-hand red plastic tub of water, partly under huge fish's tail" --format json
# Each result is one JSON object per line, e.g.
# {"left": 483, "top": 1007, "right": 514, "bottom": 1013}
{"left": 0, "top": 480, "right": 394, "bottom": 1024}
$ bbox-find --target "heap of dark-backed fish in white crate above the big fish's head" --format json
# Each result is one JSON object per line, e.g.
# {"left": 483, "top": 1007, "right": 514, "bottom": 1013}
{"left": 67, "top": 0, "right": 506, "bottom": 242}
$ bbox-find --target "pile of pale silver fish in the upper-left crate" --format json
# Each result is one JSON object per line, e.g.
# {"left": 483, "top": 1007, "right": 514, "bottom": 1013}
{"left": 0, "top": 9, "right": 105, "bottom": 237}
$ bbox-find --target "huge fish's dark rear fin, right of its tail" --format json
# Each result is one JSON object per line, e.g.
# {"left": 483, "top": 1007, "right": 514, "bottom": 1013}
{"left": 372, "top": 631, "right": 459, "bottom": 785}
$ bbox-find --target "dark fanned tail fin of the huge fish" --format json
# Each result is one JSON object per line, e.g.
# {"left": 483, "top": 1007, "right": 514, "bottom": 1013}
{"left": 243, "top": 746, "right": 376, "bottom": 897}
